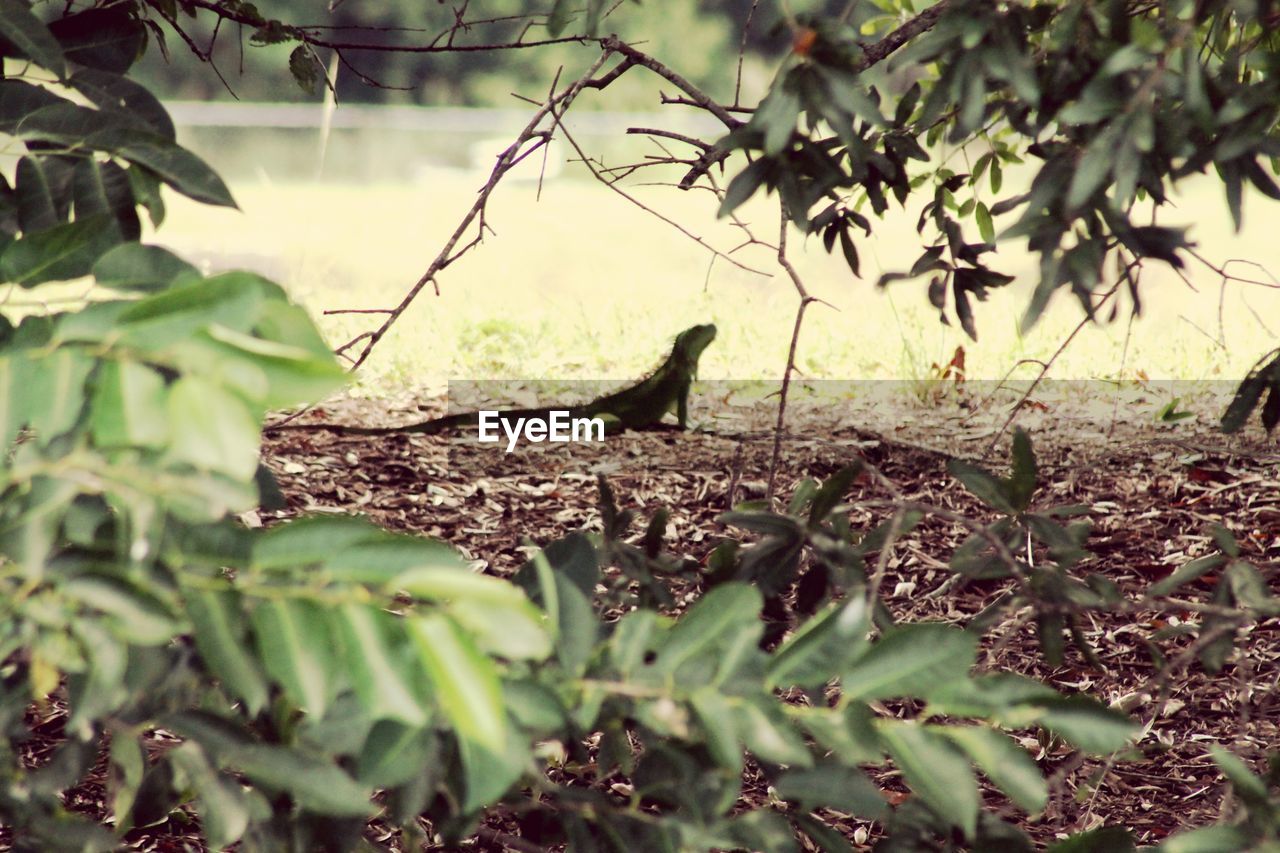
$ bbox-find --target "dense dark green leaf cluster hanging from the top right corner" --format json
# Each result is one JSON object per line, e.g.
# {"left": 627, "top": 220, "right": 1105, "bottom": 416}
{"left": 722, "top": 0, "right": 1280, "bottom": 334}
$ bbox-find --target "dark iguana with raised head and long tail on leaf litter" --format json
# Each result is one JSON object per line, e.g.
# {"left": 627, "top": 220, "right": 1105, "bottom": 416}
{"left": 276, "top": 323, "right": 716, "bottom": 435}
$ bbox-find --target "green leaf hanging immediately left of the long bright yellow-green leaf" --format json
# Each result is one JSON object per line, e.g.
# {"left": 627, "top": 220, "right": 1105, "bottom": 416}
{"left": 329, "top": 603, "right": 428, "bottom": 722}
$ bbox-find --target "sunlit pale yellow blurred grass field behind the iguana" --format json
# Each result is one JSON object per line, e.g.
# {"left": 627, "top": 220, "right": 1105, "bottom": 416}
{"left": 159, "top": 155, "right": 1280, "bottom": 396}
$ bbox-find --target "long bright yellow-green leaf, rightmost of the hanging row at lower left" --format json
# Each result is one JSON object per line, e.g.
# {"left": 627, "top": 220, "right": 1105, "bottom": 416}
{"left": 406, "top": 613, "right": 522, "bottom": 812}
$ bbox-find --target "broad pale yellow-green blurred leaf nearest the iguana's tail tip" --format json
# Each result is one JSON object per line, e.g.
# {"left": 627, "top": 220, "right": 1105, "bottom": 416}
{"left": 169, "top": 375, "right": 259, "bottom": 482}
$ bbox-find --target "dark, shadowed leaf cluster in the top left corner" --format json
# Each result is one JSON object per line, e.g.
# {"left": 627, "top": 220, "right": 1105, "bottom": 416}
{"left": 0, "top": 1, "right": 234, "bottom": 287}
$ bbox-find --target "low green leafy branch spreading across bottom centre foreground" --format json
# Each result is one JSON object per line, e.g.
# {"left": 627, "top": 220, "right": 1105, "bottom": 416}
{"left": 494, "top": 507, "right": 1135, "bottom": 850}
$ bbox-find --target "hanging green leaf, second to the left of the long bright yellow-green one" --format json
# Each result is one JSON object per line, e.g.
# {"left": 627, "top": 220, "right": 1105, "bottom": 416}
{"left": 250, "top": 598, "right": 337, "bottom": 719}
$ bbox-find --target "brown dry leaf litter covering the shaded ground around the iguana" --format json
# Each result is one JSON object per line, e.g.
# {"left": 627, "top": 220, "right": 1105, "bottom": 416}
{"left": 12, "top": 384, "right": 1280, "bottom": 850}
